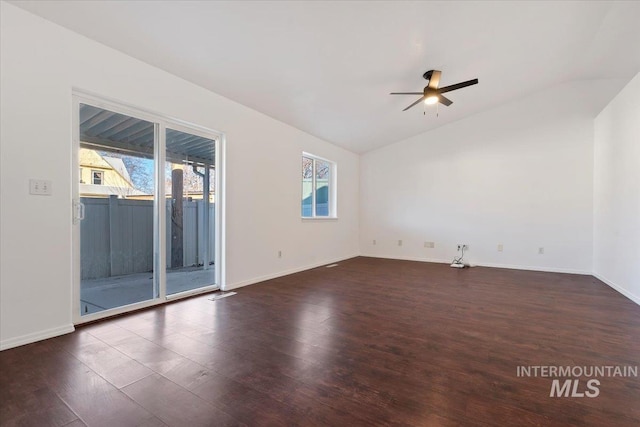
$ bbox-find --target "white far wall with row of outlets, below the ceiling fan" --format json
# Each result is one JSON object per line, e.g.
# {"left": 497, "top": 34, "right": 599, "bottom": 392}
{"left": 360, "top": 79, "right": 624, "bottom": 274}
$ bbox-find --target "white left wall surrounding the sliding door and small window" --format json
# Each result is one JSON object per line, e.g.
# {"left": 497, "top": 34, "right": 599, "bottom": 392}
{"left": 0, "top": 2, "right": 359, "bottom": 348}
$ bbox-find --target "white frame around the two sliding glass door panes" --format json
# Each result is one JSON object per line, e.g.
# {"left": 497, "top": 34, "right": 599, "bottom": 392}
{"left": 71, "top": 88, "right": 226, "bottom": 325}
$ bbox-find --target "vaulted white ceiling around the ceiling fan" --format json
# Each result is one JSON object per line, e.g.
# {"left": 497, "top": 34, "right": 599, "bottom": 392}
{"left": 12, "top": 1, "right": 640, "bottom": 152}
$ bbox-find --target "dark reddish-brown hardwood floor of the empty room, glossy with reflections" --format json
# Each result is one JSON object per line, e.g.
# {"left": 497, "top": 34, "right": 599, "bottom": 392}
{"left": 0, "top": 258, "right": 640, "bottom": 426}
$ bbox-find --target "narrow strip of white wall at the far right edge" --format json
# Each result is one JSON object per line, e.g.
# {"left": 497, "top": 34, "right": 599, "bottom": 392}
{"left": 593, "top": 74, "right": 640, "bottom": 304}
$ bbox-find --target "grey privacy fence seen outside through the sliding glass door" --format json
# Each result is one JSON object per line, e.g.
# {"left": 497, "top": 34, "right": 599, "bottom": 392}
{"left": 80, "top": 196, "right": 215, "bottom": 279}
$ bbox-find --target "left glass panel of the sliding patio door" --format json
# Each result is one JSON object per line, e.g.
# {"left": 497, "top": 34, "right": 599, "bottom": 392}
{"left": 78, "top": 104, "right": 158, "bottom": 315}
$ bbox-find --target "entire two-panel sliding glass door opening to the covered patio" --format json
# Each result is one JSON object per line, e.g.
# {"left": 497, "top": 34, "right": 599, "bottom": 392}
{"left": 74, "top": 96, "right": 219, "bottom": 322}
